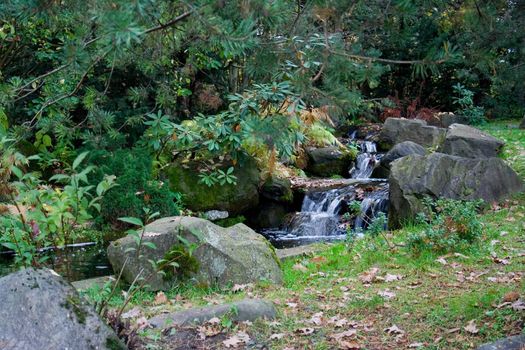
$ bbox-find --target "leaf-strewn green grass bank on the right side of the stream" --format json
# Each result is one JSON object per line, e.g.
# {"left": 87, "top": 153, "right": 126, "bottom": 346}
{"left": 87, "top": 122, "right": 525, "bottom": 349}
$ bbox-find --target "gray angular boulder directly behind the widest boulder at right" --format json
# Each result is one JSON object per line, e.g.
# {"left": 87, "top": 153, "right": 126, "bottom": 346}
{"left": 440, "top": 124, "right": 505, "bottom": 158}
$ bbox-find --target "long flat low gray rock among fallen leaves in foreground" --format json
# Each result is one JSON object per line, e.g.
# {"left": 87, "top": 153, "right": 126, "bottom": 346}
{"left": 148, "top": 299, "right": 276, "bottom": 328}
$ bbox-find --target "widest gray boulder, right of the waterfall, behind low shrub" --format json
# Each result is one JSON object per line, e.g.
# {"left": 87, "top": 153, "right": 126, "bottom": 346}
{"left": 388, "top": 153, "right": 523, "bottom": 228}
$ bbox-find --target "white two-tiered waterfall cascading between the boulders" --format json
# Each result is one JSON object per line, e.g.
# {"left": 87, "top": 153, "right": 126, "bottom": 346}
{"left": 262, "top": 133, "right": 388, "bottom": 248}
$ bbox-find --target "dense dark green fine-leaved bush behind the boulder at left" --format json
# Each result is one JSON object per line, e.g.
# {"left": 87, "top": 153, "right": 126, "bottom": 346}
{"left": 91, "top": 148, "right": 180, "bottom": 224}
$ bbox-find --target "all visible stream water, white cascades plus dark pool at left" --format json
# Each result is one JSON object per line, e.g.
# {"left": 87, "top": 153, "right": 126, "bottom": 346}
{"left": 0, "top": 133, "right": 388, "bottom": 281}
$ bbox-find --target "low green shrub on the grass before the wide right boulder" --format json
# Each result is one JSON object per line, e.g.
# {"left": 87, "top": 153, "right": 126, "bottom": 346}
{"left": 407, "top": 199, "right": 482, "bottom": 254}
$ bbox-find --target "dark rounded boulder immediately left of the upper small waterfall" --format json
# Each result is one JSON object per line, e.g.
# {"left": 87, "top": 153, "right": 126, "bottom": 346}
{"left": 306, "top": 147, "right": 353, "bottom": 177}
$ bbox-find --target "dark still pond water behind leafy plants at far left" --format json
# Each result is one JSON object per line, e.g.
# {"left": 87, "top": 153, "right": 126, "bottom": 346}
{"left": 0, "top": 244, "right": 113, "bottom": 282}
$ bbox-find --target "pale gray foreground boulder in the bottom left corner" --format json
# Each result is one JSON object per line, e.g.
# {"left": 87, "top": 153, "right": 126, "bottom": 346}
{"left": 0, "top": 268, "right": 126, "bottom": 350}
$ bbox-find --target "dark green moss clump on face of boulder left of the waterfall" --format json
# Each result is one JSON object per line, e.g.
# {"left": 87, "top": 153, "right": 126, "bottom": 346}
{"left": 161, "top": 243, "right": 199, "bottom": 281}
